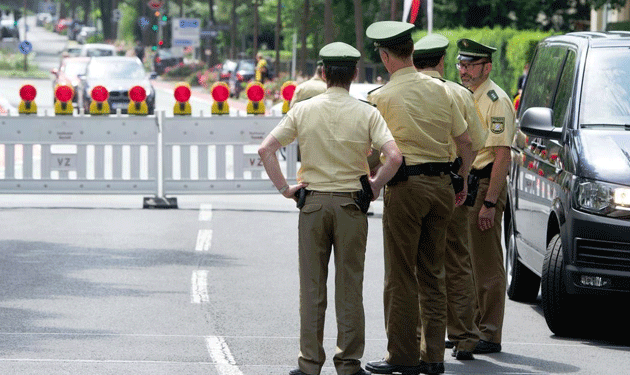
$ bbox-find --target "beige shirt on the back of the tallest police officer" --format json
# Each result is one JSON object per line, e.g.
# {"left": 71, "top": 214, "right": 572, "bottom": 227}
{"left": 368, "top": 66, "right": 467, "bottom": 165}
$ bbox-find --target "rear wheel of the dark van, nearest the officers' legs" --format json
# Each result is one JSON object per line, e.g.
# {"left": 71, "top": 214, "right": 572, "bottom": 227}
{"left": 505, "top": 220, "right": 540, "bottom": 302}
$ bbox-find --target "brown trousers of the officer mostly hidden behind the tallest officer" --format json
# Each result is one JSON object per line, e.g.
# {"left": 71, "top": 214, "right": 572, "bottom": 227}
{"left": 418, "top": 206, "right": 479, "bottom": 352}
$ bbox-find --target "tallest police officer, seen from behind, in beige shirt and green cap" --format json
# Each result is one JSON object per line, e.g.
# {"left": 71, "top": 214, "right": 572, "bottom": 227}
{"left": 366, "top": 21, "right": 472, "bottom": 374}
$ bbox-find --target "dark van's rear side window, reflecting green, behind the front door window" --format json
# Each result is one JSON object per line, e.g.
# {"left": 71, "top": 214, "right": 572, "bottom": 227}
{"left": 519, "top": 46, "right": 567, "bottom": 117}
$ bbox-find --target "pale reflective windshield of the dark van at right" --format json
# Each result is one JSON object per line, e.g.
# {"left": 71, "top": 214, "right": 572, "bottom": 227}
{"left": 580, "top": 47, "right": 630, "bottom": 126}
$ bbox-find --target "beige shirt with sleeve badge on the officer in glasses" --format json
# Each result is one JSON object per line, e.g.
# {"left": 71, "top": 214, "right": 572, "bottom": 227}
{"left": 473, "top": 79, "right": 516, "bottom": 169}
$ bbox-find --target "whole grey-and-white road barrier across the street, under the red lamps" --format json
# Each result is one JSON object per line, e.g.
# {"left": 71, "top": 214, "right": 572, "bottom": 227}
{"left": 0, "top": 111, "right": 298, "bottom": 207}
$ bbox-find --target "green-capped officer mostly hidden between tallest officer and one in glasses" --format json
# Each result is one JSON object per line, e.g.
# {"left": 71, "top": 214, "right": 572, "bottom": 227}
{"left": 413, "top": 34, "right": 488, "bottom": 360}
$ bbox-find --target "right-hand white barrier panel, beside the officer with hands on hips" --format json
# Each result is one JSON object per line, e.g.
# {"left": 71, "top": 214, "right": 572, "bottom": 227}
{"left": 161, "top": 116, "right": 297, "bottom": 195}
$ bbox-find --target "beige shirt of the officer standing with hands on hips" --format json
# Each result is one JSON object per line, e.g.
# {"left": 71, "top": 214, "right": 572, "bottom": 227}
{"left": 271, "top": 87, "right": 394, "bottom": 192}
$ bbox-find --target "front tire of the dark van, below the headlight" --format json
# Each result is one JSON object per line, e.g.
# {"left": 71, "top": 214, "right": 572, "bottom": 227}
{"left": 541, "top": 234, "right": 578, "bottom": 336}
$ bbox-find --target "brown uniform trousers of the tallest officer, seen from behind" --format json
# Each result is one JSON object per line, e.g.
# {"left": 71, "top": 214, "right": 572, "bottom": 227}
{"left": 383, "top": 174, "right": 455, "bottom": 366}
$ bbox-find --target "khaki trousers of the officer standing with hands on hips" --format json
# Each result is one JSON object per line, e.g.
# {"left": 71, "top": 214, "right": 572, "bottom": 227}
{"left": 298, "top": 192, "right": 368, "bottom": 375}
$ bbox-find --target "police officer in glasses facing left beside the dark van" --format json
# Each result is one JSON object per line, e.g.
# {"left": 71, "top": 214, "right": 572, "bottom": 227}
{"left": 457, "top": 39, "right": 516, "bottom": 353}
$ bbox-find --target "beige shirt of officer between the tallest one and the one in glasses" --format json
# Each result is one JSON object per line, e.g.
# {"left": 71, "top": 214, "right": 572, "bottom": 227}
{"left": 422, "top": 70, "right": 488, "bottom": 161}
